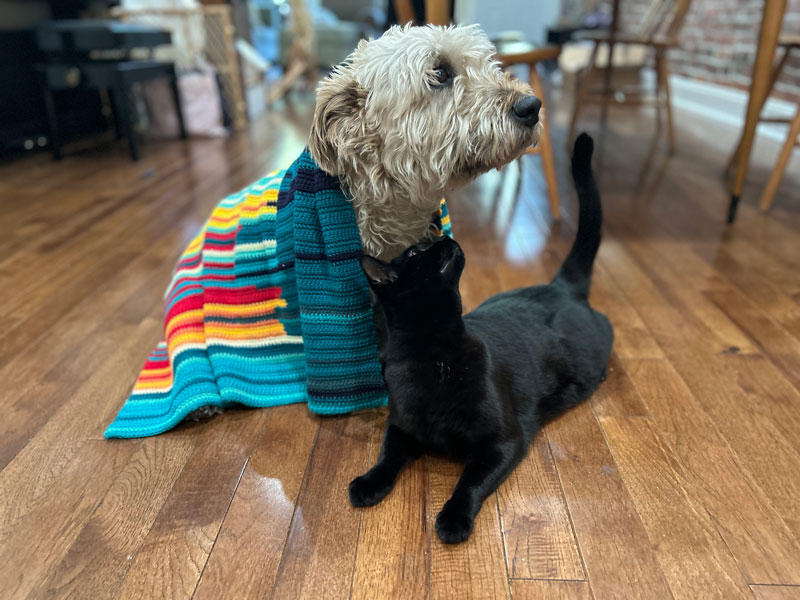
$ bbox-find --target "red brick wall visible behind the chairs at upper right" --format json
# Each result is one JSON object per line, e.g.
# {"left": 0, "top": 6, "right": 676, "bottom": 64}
{"left": 620, "top": 0, "right": 800, "bottom": 102}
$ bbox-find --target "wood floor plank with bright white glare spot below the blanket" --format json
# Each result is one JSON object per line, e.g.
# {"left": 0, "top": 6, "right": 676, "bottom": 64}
{"left": 194, "top": 404, "right": 319, "bottom": 599}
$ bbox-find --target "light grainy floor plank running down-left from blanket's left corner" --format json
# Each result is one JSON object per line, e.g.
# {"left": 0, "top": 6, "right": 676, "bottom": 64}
{"left": 31, "top": 430, "right": 200, "bottom": 599}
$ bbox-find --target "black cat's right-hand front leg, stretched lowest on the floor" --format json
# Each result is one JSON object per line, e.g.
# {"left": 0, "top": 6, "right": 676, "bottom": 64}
{"left": 436, "top": 440, "right": 525, "bottom": 544}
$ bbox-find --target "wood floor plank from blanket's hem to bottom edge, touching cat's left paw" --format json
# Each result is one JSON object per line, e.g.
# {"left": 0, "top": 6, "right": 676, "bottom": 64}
{"left": 272, "top": 411, "right": 380, "bottom": 599}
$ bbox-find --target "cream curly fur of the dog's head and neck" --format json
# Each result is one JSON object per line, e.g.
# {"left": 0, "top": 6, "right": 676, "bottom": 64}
{"left": 309, "top": 26, "right": 541, "bottom": 259}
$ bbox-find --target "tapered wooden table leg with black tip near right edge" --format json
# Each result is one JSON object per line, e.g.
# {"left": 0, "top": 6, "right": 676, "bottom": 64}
{"left": 728, "top": 0, "right": 786, "bottom": 223}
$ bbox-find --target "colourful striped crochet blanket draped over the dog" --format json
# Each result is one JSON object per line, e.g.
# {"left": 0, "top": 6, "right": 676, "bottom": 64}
{"left": 105, "top": 150, "right": 450, "bottom": 438}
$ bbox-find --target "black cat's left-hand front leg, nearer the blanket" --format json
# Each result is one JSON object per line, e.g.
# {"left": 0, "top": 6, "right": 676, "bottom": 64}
{"left": 350, "top": 424, "right": 422, "bottom": 506}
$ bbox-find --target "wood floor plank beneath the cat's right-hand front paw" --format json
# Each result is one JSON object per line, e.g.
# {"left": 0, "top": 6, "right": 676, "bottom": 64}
{"left": 424, "top": 456, "right": 510, "bottom": 599}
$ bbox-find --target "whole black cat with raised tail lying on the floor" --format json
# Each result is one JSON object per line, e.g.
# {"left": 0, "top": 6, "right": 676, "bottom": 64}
{"left": 350, "top": 134, "right": 613, "bottom": 543}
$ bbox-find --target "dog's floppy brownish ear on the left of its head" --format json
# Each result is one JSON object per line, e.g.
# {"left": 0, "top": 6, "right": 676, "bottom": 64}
{"left": 308, "top": 69, "right": 367, "bottom": 175}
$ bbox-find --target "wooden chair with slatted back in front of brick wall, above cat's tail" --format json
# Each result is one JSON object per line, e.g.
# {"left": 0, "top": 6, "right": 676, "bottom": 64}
{"left": 567, "top": 0, "right": 690, "bottom": 152}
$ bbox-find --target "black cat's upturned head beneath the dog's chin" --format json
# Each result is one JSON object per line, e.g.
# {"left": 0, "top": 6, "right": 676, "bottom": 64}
{"left": 361, "top": 236, "right": 464, "bottom": 329}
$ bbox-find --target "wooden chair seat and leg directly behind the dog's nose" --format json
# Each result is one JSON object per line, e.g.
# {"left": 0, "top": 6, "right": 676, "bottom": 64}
{"left": 495, "top": 42, "right": 561, "bottom": 220}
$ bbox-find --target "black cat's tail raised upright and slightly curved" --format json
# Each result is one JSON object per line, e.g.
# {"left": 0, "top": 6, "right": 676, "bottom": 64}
{"left": 554, "top": 133, "right": 603, "bottom": 298}
